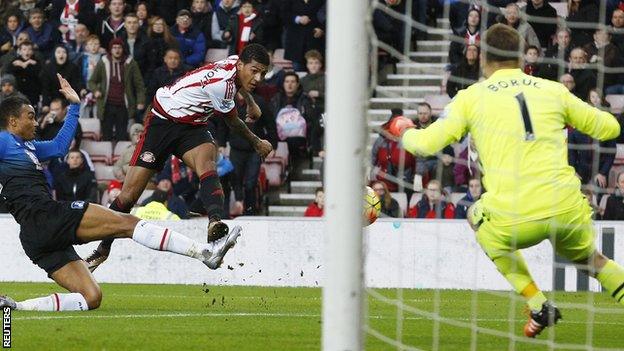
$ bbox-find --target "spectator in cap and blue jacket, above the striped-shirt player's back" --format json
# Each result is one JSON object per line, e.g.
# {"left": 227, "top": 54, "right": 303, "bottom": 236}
{"left": 171, "top": 10, "right": 206, "bottom": 67}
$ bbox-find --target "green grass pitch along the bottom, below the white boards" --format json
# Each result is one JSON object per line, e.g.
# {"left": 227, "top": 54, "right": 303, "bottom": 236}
{"left": 0, "top": 283, "right": 624, "bottom": 351}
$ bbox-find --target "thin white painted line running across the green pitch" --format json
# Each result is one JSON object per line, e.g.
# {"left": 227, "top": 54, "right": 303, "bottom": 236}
{"left": 12, "top": 312, "right": 624, "bottom": 325}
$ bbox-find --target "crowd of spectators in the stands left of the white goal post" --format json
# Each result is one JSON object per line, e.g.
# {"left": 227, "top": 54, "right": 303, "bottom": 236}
{"left": 0, "top": 0, "right": 326, "bottom": 218}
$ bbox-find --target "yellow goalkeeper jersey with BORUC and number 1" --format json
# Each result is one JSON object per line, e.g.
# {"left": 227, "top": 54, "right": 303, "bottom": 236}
{"left": 402, "top": 69, "right": 620, "bottom": 225}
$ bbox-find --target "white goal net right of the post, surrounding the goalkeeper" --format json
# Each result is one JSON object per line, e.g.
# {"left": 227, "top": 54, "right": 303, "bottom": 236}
{"left": 324, "top": 0, "right": 624, "bottom": 350}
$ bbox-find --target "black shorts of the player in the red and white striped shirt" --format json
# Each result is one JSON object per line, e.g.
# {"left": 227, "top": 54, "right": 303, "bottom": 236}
{"left": 130, "top": 111, "right": 215, "bottom": 171}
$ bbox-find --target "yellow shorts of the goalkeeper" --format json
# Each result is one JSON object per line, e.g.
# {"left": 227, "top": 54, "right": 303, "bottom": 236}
{"left": 468, "top": 198, "right": 596, "bottom": 262}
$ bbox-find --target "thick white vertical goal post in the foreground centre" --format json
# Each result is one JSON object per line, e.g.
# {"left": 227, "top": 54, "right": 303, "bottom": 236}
{"left": 322, "top": 0, "right": 370, "bottom": 350}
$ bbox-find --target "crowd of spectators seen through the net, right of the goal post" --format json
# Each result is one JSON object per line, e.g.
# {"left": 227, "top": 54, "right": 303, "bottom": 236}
{"left": 372, "top": 0, "right": 624, "bottom": 220}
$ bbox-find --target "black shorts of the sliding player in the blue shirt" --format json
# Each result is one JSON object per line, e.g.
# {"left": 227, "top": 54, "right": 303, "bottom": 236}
{"left": 19, "top": 199, "right": 89, "bottom": 277}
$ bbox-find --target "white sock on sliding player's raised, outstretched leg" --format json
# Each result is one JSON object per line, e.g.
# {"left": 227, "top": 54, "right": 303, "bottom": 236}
{"left": 132, "top": 220, "right": 208, "bottom": 259}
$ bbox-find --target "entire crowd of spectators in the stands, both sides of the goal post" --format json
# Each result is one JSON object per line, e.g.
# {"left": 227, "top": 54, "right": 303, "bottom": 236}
{"left": 0, "top": 0, "right": 624, "bottom": 219}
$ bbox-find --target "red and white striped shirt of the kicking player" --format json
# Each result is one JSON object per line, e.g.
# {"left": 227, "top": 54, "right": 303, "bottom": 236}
{"left": 152, "top": 56, "right": 238, "bottom": 125}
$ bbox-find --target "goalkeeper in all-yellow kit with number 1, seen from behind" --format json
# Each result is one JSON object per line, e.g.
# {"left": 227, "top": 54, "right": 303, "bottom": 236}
{"left": 392, "top": 24, "right": 624, "bottom": 337}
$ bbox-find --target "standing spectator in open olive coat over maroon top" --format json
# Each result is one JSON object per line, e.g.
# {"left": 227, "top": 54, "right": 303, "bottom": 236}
{"left": 89, "top": 38, "right": 145, "bottom": 141}
